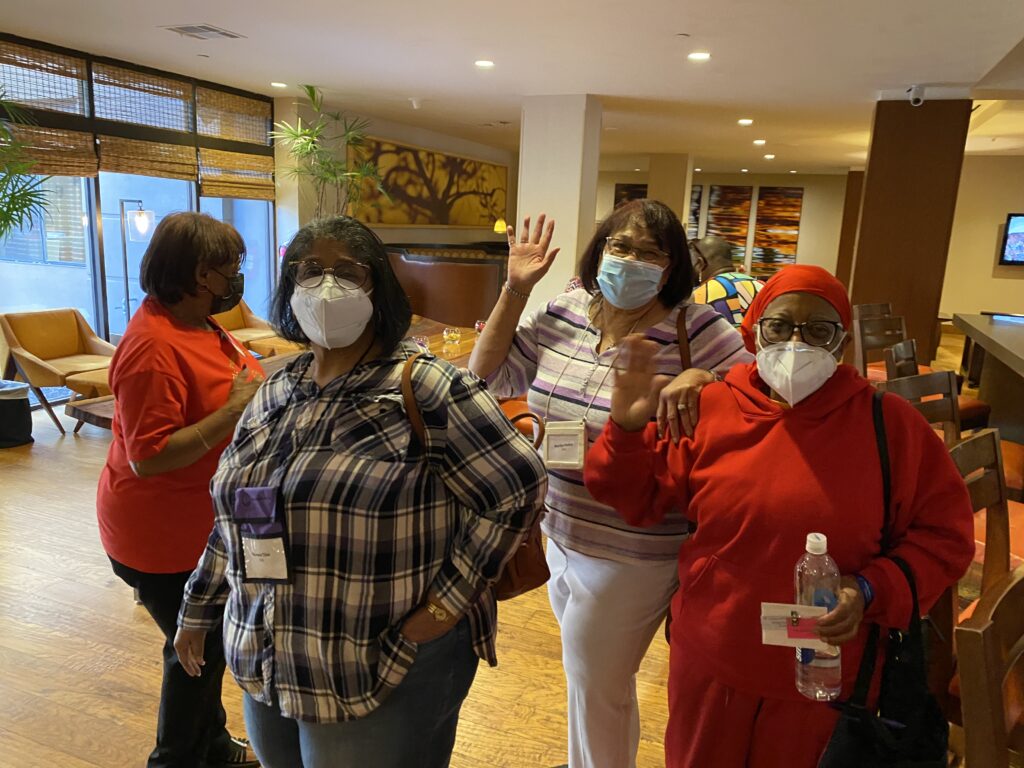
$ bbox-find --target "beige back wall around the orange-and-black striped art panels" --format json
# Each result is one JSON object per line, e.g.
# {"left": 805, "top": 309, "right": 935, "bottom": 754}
{"left": 595, "top": 171, "right": 846, "bottom": 271}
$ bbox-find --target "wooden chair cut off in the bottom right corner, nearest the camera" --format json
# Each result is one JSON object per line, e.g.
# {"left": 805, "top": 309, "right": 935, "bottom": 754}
{"left": 956, "top": 566, "right": 1024, "bottom": 768}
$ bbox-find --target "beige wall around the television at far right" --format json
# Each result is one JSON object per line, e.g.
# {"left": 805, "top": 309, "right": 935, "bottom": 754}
{"left": 939, "top": 158, "right": 1024, "bottom": 314}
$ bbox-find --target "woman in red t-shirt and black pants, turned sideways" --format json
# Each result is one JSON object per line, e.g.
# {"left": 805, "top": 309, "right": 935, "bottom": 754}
{"left": 96, "top": 213, "right": 263, "bottom": 768}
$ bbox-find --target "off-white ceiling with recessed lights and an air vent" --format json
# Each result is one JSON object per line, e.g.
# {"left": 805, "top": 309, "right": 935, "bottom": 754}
{"left": 6, "top": 0, "right": 1024, "bottom": 173}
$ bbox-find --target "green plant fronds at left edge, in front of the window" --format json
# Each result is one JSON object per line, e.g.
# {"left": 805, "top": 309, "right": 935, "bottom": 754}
{"left": 0, "top": 85, "right": 47, "bottom": 242}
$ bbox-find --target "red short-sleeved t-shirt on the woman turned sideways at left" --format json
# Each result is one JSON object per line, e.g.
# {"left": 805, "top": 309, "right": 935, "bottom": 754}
{"left": 96, "top": 297, "right": 262, "bottom": 573}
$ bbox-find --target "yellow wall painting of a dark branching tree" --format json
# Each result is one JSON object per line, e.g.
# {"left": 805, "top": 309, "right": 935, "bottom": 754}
{"left": 355, "top": 138, "right": 508, "bottom": 228}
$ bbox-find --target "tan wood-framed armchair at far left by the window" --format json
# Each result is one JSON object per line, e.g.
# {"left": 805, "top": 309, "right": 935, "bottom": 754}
{"left": 0, "top": 308, "right": 115, "bottom": 434}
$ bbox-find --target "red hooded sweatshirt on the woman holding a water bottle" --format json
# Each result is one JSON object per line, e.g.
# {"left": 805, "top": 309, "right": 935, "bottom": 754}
{"left": 584, "top": 364, "right": 974, "bottom": 700}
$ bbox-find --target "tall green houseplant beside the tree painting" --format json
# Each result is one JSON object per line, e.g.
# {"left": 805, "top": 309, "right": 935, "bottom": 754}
{"left": 270, "top": 85, "right": 386, "bottom": 218}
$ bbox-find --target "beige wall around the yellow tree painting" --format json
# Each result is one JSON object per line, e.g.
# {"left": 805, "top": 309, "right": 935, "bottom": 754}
{"left": 274, "top": 98, "right": 518, "bottom": 245}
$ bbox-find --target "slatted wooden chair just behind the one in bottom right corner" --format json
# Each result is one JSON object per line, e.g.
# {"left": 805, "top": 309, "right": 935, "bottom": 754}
{"left": 928, "top": 429, "right": 1010, "bottom": 725}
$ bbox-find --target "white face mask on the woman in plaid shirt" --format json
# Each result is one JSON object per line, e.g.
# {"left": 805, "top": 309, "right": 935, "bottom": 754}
{"left": 291, "top": 274, "right": 374, "bottom": 349}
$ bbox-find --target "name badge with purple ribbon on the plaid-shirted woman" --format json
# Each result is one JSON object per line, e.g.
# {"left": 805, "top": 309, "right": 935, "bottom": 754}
{"left": 232, "top": 486, "right": 289, "bottom": 584}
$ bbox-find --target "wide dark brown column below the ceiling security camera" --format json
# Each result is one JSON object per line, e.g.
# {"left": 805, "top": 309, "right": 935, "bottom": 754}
{"left": 850, "top": 99, "right": 971, "bottom": 361}
